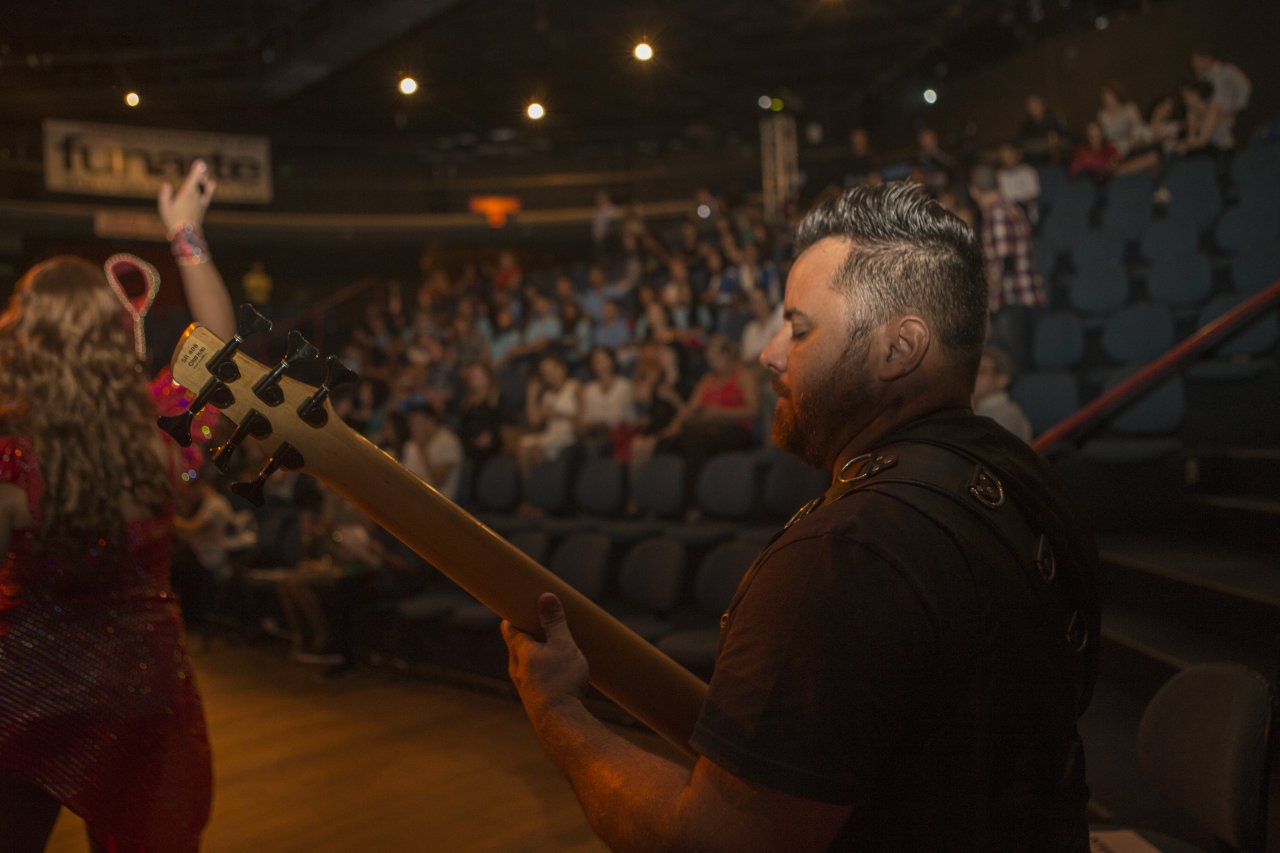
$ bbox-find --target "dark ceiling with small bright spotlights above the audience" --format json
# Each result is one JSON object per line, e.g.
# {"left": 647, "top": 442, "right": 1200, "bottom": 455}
{"left": 0, "top": 0, "right": 1140, "bottom": 150}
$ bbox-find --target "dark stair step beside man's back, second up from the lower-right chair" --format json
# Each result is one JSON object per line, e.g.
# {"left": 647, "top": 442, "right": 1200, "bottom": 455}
{"left": 1098, "top": 535, "right": 1280, "bottom": 607}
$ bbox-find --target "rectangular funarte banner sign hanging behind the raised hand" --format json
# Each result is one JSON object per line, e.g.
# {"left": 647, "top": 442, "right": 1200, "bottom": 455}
{"left": 45, "top": 119, "right": 271, "bottom": 204}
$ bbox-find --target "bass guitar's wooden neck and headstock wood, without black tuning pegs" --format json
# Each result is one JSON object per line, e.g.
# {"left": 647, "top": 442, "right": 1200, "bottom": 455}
{"left": 173, "top": 324, "right": 707, "bottom": 754}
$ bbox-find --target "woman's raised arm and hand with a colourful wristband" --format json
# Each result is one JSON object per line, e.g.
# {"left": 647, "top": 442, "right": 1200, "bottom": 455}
{"left": 156, "top": 160, "right": 236, "bottom": 341}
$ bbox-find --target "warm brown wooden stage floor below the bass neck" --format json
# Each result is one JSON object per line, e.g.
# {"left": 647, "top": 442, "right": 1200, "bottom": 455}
{"left": 47, "top": 643, "right": 672, "bottom": 853}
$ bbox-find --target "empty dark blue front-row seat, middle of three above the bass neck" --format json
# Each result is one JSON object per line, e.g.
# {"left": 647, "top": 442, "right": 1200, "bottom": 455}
{"left": 608, "top": 537, "right": 687, "bottom": 643}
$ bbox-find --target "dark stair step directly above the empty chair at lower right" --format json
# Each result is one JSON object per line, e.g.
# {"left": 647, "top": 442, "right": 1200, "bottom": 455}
{"left": 1102, "top": 605, "right": 1271, "bottom": 672}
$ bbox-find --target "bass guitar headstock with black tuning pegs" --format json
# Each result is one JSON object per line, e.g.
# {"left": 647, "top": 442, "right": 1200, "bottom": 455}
{"left": 159, "top": 305, "right": 356, "bottom": 505}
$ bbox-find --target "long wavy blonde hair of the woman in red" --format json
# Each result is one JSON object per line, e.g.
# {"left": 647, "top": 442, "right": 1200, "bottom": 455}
{"left": 0, "top": 256, "right": 172, "bottom": 540}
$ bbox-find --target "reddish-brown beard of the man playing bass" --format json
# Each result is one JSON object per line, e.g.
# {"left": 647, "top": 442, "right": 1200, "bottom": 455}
{"left": 772, "top": 337, "right": 872, "bottom": 469}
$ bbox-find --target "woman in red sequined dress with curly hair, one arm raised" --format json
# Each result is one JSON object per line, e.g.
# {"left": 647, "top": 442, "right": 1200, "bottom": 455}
{"left": 0, "top": 161, "right": 234, "bottom": 853}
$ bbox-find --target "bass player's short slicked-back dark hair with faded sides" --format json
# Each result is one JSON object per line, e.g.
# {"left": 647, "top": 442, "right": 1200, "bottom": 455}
{"left": 796, "top": 182, "right": 987, "bottom": 380}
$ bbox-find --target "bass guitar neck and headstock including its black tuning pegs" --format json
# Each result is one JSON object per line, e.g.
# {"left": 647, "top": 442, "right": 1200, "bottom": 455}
{"left": 160, "top": 313, "right": 707, "bottom": 754}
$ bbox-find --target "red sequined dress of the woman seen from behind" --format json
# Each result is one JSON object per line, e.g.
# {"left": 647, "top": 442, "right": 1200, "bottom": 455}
{"left": 0, "top": 371, "right": 212, "bottom": 853}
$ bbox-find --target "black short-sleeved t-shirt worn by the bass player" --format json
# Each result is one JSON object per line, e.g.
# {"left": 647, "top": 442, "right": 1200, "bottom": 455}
{"left": 691, "top": 411, "right": 1096, "bottom": 853}
